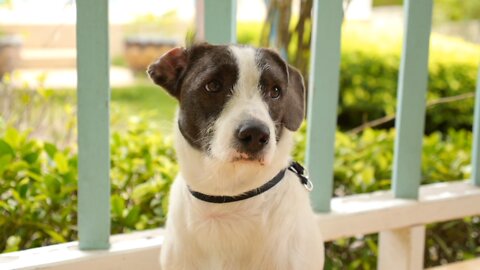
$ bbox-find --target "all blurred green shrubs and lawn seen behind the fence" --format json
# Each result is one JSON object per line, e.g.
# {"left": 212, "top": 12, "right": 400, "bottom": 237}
{"left": 0, "top": 0, "right": 480, "bottom": 269}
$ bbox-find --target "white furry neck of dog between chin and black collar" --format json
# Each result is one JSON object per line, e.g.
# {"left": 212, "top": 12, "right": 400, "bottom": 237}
{"left": 175, "top": 122, "right": 293, "bottom": 196}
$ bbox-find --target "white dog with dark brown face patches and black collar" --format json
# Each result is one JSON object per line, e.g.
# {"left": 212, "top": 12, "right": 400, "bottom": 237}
{"left": 147, "top": 43, "right": 324, "bottom": 270}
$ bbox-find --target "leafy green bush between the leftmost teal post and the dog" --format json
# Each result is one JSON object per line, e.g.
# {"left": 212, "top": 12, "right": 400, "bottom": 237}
{"left": 110, "top": 118, "right": 178, "bottom": 233}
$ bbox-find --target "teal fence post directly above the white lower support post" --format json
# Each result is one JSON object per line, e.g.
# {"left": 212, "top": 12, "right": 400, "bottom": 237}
{"left": 393, "top": 0, "right": 432, "bottom": 199}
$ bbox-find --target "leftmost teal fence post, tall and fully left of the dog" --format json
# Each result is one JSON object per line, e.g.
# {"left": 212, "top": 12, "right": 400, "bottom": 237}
{"left": 76, "top": 0, "right": 110, "bottom": 250}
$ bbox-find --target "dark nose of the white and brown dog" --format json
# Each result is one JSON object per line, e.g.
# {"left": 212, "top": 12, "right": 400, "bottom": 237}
{"left": 237, "top": 120, "right": 270, "bottom": 153}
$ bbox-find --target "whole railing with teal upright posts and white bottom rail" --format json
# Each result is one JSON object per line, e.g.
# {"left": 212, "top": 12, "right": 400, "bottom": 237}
{"left": 0, "top": 0, "right": 480, "bottom": 270}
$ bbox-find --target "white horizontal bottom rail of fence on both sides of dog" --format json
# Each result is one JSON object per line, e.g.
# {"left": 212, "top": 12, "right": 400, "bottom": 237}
{"left": 0, "top": 181, "right": 480, "bottom": 270}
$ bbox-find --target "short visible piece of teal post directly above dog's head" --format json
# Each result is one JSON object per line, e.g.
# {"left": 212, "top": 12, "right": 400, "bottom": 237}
{"left": 202, "top": 0, "right": 237, "bottom": 44}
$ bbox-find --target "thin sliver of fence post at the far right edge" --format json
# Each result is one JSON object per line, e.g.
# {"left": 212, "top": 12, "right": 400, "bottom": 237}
{"left": 472, "top": 65, "right": 480, "bottom": 187}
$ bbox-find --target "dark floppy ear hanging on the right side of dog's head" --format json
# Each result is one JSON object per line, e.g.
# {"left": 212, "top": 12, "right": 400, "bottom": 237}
{"left": 283, "top": 64, "right": 305, "bottom": 131}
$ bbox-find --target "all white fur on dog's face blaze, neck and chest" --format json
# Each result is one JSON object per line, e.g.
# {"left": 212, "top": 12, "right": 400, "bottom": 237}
{"left": 160, "top": 47, "right": 323, "bottom": 270}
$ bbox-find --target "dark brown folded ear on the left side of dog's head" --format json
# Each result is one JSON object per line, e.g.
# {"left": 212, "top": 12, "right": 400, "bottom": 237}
{"left": 147, "top": 47, "right": 188, "bottom": 99}
